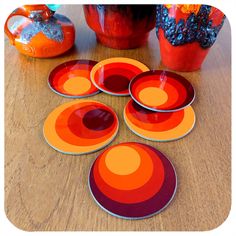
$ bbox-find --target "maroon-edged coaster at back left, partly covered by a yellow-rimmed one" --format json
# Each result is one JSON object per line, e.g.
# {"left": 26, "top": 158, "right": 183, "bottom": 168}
{"left": 48, "top": 60, "right": 100, "bottom": 98}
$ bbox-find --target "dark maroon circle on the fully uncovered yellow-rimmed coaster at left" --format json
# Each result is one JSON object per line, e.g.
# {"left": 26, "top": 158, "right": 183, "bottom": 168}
{"left": 83, "top": 108, "right": 114, "bottom": 131}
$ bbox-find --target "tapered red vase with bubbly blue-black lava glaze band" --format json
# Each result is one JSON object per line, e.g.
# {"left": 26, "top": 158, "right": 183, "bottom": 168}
{"left": 157, "top": 4, "right": 225, "bottom": 72}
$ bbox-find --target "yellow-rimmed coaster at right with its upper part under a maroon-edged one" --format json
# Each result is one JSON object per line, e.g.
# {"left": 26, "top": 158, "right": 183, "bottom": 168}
{"left": 124, "top": 100, "right": 195, "bottom": 141}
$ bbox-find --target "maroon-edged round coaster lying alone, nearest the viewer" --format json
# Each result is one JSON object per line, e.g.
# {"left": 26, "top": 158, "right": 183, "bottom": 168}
{"left": 89, "top": 142, "right": 177, "bottom": 219}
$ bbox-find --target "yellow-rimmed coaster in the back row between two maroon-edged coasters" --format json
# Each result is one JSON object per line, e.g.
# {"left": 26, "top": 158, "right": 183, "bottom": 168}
{"left": 91, "top": 57, "right": 149, "bottom": 96}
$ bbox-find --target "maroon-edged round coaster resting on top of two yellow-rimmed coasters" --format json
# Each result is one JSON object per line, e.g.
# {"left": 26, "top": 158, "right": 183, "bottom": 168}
{"left": 129, "top": 70, "right": 195, "bottom": 112}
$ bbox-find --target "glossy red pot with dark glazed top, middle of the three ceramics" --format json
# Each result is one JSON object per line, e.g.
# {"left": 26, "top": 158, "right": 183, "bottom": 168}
{"left": 83, "top": 5, "right": 156, "bottom": 49}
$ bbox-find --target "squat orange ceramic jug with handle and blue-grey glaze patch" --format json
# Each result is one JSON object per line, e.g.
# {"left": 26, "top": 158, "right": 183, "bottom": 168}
{"left": 4, "top": 5, "right": 75, "bottom": 58}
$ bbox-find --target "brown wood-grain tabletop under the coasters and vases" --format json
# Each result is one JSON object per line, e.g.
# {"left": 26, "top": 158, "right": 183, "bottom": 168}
{"left": 5, "top": 5, "right": 231, "bottom": 231}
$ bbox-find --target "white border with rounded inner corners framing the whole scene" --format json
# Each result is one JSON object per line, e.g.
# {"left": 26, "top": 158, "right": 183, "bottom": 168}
{"left": 0, "top": 0, "right": 236, "bottom": 236}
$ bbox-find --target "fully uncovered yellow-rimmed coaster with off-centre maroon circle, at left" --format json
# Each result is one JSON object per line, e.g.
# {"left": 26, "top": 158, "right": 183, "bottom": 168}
{"left": 43, "top": 100, "right": 119, "bottom": 155}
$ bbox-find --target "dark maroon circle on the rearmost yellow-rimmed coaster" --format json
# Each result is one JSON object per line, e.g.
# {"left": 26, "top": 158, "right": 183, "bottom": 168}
{"left": 104, "top": 75, "right": 130, "bottom": 92}
